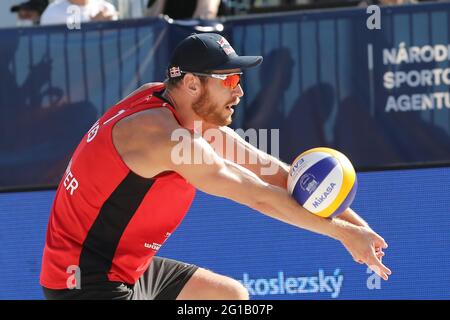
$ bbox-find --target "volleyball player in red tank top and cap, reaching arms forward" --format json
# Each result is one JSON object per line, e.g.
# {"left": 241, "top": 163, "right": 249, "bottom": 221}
{"left": 41, "top": 33, "right": 391, "bottom": 299}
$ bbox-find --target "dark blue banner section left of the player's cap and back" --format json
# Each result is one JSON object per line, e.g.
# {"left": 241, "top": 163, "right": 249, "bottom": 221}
{"left": 0, "top": 19, "right": 168, "bottom": 188}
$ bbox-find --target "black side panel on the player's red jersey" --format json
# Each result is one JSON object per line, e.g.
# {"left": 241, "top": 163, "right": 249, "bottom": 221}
{"left": 79, "top": 171, "right": 155, "bottom": 286}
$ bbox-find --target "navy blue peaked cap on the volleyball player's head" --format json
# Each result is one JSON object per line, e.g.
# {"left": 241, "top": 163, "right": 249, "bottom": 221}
{"left": 168, "top": 33, "right": 263, "bottom": 78}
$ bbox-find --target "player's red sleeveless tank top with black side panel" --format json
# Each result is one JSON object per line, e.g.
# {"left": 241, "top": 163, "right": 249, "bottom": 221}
{"left": 40, "top": 84, "right": 195, "bottom": 289}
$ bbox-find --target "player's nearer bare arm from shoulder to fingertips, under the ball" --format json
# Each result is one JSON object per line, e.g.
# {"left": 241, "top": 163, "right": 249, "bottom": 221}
{"left": 113, "top": 110, "right": 390, "bottom": 279}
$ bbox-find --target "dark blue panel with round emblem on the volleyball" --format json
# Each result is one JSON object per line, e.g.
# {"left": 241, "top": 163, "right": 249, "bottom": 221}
{"left": 292, "top": 157, "right": 339, "bottom": 205}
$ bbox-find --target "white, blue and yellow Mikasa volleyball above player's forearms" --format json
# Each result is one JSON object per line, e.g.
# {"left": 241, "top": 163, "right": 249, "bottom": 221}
{"left": 287, "top": 147, "right": 357, "bottom": 218}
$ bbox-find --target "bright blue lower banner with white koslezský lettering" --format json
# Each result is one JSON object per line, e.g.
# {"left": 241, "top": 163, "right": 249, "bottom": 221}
{"left": 0, "top": 167, "right": 450, "bottom": 299}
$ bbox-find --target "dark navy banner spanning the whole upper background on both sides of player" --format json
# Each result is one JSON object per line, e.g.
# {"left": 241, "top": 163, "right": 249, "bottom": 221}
{"left": 0, "top": 3, "right": 450, "bottom": 190}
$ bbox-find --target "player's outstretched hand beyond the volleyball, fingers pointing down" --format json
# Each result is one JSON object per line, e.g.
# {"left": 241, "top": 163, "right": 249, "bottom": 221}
{"left": 341, "top": 226, "right": 392, "bottom": 280}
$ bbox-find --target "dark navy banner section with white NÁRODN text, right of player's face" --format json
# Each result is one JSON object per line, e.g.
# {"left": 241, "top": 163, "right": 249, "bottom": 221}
{"left": 227, "top": 4, "right": 450, "bottom": 168}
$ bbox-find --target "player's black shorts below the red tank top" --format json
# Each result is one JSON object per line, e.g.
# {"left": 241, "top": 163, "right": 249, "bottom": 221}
{"left": 42, "top": 257, "right": 198, "bottom": 300}
